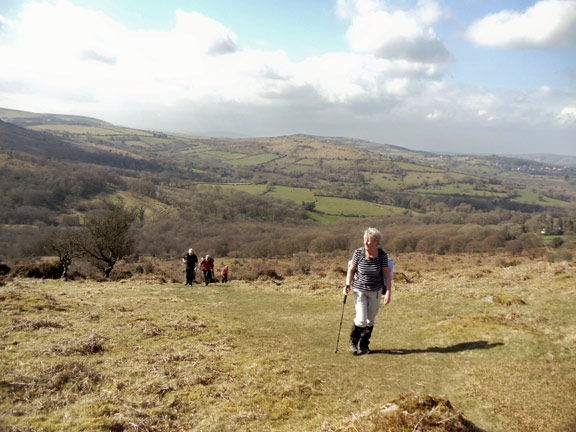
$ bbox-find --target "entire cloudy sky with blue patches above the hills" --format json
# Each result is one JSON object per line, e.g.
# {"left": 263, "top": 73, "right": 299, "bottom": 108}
{"left": 0, "top": 0, "right": 576, "bottom": 155}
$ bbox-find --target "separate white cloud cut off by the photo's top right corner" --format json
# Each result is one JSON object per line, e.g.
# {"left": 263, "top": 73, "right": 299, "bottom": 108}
{"left": 467, "top": 0, "right": 576, "bottom": 48}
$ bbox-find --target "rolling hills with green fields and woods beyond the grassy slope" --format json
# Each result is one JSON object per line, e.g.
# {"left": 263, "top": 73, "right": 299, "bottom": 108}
{"left": 0, "top": 105, "right": 576, "bottom": 260}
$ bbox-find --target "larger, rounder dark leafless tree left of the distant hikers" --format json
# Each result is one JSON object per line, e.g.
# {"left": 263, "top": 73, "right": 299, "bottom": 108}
{"left": 79, "top": 206, "right": 136, "bottom": 278}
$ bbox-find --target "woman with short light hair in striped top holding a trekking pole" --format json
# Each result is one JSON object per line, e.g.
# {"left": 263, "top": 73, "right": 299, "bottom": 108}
{"left": 343, "top": 228, "right": 392, "bottom": 355}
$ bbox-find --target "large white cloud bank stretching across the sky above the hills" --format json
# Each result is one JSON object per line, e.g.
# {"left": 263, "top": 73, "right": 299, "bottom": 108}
{"left": 0, "top": 0, "right": 575, "bottom": 155}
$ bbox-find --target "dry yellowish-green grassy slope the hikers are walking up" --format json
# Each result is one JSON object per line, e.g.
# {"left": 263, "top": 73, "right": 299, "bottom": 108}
{"left": 0, "top": 254, "right": 576, "bottom": 432}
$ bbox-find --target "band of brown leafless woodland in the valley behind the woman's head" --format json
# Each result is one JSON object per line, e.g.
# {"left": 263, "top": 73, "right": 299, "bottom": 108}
{"left": 138, "top": 211, "right": 574, "bottom": 258}
